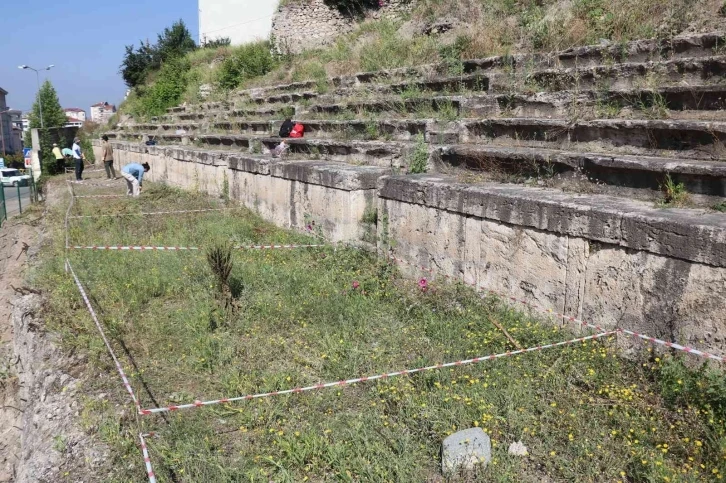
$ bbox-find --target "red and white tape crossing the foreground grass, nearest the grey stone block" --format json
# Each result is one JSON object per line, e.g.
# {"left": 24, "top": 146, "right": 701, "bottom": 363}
{"left": 140, "top": 331, "right": 616, "bottom": 415}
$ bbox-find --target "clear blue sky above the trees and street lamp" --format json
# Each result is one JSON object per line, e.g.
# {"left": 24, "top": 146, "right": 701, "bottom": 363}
{"left": 0, "top": 0, "right": 199, "bottom": 116}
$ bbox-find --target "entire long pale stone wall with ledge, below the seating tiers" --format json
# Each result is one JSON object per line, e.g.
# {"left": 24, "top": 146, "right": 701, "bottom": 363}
{"left": 96, "top": 142, "right": 726, "bottom": 354}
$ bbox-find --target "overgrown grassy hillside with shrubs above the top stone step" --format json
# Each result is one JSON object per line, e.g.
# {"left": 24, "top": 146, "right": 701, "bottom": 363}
{"left": 122, "top": 0, "right": 721, "bottom": 121}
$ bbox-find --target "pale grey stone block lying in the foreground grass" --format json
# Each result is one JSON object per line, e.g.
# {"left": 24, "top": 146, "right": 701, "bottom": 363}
{"left": 441, "top": 428, "right": 492, "bottom": 474}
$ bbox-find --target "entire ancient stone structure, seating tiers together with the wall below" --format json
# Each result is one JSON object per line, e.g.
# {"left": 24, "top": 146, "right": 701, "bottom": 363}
{"left": 95, "top": 34, "right": 726, "bottom": 354}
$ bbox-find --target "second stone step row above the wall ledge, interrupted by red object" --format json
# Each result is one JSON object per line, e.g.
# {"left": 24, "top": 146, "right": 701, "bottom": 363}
{"left": 114, "top": 118, "right": 726, "bottom": 160}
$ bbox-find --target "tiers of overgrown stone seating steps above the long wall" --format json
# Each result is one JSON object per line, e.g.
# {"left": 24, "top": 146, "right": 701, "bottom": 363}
{"left": 107, "top": 33, "right": 726, "bottom": 208}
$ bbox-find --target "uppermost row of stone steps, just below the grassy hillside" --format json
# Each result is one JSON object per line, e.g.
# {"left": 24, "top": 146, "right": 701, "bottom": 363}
{"left": 237, "top": 32, "right": 726, "bottom": 102}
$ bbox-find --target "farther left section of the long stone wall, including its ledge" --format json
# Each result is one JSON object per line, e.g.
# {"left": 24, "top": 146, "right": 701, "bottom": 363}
{"left": 99, "top": 142, "right": 390, "bottom": 246}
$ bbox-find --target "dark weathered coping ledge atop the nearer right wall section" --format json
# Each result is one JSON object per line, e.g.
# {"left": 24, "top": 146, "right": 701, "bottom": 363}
{"left": 380, "top": 175, "right": 726, "bottom": 267}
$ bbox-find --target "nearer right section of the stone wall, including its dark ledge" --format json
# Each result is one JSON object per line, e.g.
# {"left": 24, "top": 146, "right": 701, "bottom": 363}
{"left": 378, "top": 176, "right": 726, "bottom": 353}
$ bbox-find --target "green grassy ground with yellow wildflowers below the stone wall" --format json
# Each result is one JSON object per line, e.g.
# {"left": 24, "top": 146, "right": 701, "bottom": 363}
{"left": 35, "top": 178, "right": 726, "bottom": 482}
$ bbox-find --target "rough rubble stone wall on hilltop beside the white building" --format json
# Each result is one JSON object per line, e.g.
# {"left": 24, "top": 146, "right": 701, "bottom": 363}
{"left": 272, "top": 0, "right": 410, "bottom": 54}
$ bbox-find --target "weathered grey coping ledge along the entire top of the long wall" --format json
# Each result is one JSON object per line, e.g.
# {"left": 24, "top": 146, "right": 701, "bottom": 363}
{"left": 104, "top": 138, "right": 726, "bottom": 267}
